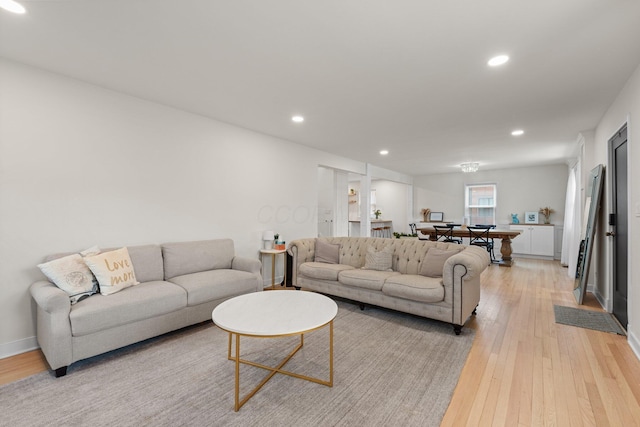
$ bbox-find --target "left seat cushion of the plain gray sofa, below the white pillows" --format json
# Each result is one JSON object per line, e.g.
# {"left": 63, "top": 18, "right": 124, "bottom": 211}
{"left": 69, "top": 281, "right": 187, "bottom": 336}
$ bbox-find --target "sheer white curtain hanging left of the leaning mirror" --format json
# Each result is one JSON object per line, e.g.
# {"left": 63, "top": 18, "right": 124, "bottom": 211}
{"left": 560, "top": 160, "right": 582, "bottom": 277}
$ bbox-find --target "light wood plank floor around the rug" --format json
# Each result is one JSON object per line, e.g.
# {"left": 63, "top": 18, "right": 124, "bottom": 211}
{"left": 0, "top": 259, "right": 640, "bottom": 427}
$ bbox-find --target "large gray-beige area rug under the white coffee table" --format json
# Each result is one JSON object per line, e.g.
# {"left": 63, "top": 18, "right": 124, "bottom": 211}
{"left": 0, "top": 301, "right": 474, "bottom": 426}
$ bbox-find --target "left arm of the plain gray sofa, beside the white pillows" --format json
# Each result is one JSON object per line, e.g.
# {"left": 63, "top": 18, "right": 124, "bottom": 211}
{"left": 29, "top": 280, "right": 73, "bottom": 370}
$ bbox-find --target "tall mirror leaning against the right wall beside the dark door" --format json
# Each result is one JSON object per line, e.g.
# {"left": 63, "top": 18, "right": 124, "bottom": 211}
{"left": 573, "top": 165, "right": 604, "bottom": 304}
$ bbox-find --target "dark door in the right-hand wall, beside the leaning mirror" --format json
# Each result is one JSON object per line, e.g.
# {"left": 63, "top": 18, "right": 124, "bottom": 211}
{"left": 610, "top": 125, "right": 628, "bottom": 329}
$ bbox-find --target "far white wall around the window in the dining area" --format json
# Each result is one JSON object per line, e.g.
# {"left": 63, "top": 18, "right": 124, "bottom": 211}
{"left": 412, "top": 164, "right": 569, "bottom": 224}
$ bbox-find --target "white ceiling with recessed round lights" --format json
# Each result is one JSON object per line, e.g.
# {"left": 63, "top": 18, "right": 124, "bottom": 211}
{"left": 0, "top": 0, "right": 640, "bottom": 175}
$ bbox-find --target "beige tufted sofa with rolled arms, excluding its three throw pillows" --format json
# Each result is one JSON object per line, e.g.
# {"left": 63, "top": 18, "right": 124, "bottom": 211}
{"left": 288, "top": 237, "right": 490, "bottom": 334}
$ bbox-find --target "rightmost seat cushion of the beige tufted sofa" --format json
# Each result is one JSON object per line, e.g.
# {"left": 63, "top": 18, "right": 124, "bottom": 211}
{"left": 382, "top": 274, "right": 444, "bottom": 302}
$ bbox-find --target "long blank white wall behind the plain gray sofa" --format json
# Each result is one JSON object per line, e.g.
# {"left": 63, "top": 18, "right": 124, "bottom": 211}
{"left": 0, "top": 59, "right": 366, "bottom": 357}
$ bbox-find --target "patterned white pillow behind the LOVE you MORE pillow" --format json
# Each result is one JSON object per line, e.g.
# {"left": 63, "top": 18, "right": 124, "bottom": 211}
{"left": 38, "top": 254, "right": 98, "bottom": 304}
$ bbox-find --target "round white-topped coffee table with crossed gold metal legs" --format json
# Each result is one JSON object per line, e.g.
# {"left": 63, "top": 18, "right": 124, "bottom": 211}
{"left": 211, "top": 290, "right": 338, "bottom": 411}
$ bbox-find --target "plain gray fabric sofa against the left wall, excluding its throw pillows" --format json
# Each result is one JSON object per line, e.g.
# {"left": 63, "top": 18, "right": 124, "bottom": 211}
{"left": 30, "top": 239, "right": 263, "bottom": 377}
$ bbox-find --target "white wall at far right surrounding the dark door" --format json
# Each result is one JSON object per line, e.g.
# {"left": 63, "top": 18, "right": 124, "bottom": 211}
{"left": 583, "top": 58, "right": 640, "bottom": 357}
